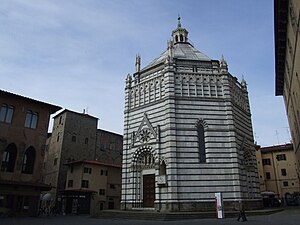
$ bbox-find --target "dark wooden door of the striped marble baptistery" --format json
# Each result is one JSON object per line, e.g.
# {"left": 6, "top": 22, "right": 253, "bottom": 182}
{"left": 143, "top": 174, "right": 155, "bottom": 208}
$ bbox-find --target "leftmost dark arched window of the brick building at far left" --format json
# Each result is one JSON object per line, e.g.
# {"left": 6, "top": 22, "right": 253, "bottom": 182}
{"left": 1, "top": 143, "right": 17, "bottom": 172}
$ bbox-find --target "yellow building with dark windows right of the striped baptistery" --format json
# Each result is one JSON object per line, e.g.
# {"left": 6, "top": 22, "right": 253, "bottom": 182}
{"left": 256, "top": 144, "right": 300, "bottom": 199}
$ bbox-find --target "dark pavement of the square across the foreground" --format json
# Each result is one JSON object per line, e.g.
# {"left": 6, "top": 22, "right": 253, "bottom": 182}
{"left": 0, "top": 207, "right": 300, "bottom": 225}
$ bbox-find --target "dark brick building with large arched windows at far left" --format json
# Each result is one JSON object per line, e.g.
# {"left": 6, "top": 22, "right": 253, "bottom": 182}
{"left": 0, "top": 90, "right": 61, "bottom": 216}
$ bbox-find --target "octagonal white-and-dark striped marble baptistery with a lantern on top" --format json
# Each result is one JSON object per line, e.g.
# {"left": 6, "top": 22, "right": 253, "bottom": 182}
{"left": 121, "top": 18, "right": 261, "bottom": 211}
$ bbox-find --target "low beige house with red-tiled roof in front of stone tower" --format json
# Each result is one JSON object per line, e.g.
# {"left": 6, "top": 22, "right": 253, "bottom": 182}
{"left": 60, "top": 160, "right": 121, "bottom": 215}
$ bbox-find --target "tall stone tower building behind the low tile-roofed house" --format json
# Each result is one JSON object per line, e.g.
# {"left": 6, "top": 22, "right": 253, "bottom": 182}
{"left": 43, "top": 109, "right": 123, "bottom": 208}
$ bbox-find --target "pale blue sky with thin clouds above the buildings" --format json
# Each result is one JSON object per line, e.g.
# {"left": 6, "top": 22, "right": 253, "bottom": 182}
{"left": 0, "top": 0, "right": 291, "bottom": 146}
